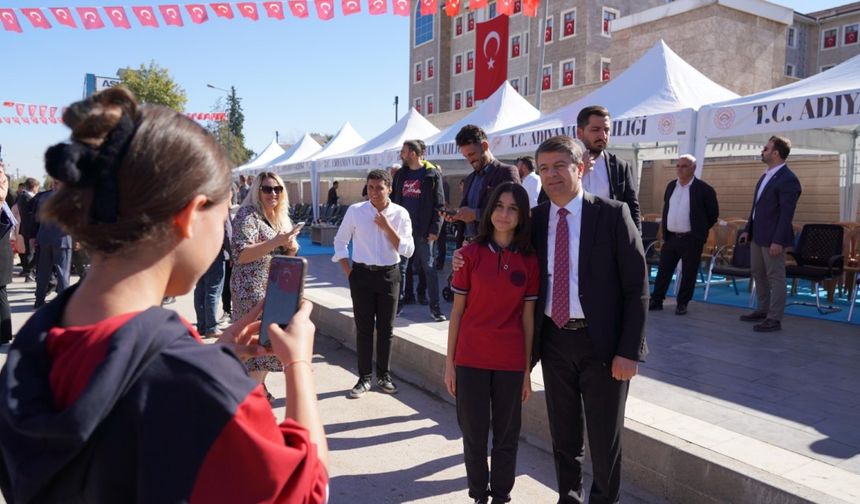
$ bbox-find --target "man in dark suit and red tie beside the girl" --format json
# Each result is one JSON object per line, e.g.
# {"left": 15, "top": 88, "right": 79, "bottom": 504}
{"left": 532, "top": 136, "right": 648, "bottom": 504}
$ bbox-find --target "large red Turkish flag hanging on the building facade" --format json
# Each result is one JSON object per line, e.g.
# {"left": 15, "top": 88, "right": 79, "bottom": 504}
{"left": 475, "top": 15, "right": 508, "bottom": 100}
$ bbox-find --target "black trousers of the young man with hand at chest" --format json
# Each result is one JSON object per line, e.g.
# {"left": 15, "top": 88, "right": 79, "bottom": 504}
{"left": 349, "top": 264, "right": 400, "bottom": 379}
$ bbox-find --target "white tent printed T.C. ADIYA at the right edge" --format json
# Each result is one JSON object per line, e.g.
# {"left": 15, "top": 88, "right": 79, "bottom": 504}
{"left": 696, "top": 56, "right": 860, "bottom": 220}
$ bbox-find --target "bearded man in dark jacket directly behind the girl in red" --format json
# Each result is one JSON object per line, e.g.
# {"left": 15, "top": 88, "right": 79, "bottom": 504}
{"left": 446, "top": 124, "right": 520, "bottom": 238}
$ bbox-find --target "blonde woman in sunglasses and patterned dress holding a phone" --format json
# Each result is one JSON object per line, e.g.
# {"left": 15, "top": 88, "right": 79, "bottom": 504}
{"left": 230, "top": 172, "right": 299, "bottom": 403}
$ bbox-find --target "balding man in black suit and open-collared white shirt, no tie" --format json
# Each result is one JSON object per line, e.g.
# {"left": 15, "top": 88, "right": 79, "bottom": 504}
{"left": 648, "top": 154, "right": 720, "bottom": 315}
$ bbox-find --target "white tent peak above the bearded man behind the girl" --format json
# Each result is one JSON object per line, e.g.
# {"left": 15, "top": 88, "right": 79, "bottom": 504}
{"left": 426, "top": 82, "right": 540, "bottom": 160}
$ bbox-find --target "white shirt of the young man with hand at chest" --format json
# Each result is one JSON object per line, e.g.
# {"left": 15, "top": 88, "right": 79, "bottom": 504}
{"left": 331, "top": 201, "right": 415, "bottom": 266}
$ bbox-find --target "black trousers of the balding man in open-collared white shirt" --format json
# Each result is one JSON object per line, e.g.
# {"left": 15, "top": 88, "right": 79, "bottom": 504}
{"left": 651, "top": 234, "right": 705, "bottom": 304}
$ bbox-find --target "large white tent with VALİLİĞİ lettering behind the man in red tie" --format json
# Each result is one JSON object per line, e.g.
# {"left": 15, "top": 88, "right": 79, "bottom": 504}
{"left": 491, "top": 40, "right": 738, "bottom": 159}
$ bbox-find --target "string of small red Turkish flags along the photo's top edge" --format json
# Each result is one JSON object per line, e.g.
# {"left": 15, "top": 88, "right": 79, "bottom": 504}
{"left": 0, "top": 0, "right": 540, "bottom": 32}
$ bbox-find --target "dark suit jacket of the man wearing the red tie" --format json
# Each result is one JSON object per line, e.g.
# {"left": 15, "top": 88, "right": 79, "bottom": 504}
{"left": 532, "top": 193, "right": 648, "bottom": 365}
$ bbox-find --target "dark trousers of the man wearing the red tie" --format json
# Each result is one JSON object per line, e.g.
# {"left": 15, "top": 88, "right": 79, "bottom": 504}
{"left": 541, "top": 317, "right": 630, "bottom": 504}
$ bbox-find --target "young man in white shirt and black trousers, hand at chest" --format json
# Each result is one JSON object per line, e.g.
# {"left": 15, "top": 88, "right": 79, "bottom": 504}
{"left": 332, "top": 170, "right": 415, "bottom": 399}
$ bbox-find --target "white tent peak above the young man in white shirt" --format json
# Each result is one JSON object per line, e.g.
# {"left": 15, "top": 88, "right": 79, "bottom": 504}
{"left": 317, "top": 108, "right": 439, "bottom": 177}
